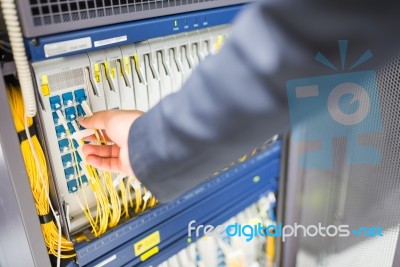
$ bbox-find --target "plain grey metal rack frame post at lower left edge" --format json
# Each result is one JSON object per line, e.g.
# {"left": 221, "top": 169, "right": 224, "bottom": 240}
{"left": 0, "top": 63, "right": 51, "bottom": 267}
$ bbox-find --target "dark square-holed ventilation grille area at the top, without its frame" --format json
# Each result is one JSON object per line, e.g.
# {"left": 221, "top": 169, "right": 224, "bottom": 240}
{"left": 29, "top": 0, "right": 217, "bottom": 26}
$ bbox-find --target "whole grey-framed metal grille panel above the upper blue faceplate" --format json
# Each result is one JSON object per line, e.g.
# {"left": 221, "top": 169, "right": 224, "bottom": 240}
{"left": 18, "top": 0, "right": 248, "bottom": 37}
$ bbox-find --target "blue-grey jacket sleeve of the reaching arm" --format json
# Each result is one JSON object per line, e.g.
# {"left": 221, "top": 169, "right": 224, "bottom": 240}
{"left": 129, "top": 0, "right": 400, "bottom": 201}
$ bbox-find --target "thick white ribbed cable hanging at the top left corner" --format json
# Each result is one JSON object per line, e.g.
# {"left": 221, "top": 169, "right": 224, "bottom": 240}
{"left": 0, "top": 0, "right": 36, "bottom": 118}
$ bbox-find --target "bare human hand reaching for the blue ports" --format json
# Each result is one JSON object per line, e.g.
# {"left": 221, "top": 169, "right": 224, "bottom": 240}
{"left": 78, "top": 110, "right": 143, "bottom": 175}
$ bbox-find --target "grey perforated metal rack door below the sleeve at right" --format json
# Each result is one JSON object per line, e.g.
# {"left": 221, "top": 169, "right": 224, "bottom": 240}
{"left": 285, "top": 56, "right": 400, "bottom": 267}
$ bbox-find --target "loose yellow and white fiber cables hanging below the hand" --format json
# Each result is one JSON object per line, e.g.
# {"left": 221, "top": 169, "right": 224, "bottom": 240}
{"left": 66, "top": 101, "right": 157, "bottom": 237}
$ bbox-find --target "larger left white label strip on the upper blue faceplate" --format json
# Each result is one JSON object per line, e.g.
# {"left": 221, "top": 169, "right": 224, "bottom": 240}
{"left": 44, "top": 37, "right": 92, "bottom": 58}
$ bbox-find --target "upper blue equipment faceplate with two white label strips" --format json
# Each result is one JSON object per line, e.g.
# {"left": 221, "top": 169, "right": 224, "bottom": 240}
{"left": 25, "top": 5, "right": 243, "bottom": 62}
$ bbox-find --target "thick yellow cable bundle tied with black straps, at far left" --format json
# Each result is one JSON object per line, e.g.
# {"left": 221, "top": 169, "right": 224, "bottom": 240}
{"left": 7, "top": 86, "right": 75, "bottom": 261}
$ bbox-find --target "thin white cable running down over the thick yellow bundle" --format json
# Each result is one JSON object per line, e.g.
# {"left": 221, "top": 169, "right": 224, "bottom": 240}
{"left": 24, "top": 115, "right": 61, "bottom": 267}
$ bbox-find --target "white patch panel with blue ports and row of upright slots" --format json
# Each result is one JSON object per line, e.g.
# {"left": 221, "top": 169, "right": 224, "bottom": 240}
{"left": 33, "top": 25, "right": 228, "bottom": 232}
